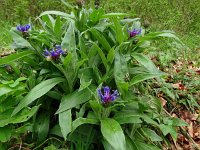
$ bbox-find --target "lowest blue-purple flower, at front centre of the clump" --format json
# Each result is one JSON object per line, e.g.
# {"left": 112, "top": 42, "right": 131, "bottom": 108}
{"left": 98, "top": 86, "right": 119, "bottom": 104}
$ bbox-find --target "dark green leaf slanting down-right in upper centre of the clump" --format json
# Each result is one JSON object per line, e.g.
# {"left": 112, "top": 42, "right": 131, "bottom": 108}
{"left": 90, "top": 28, "right": 111, "bottom": 52}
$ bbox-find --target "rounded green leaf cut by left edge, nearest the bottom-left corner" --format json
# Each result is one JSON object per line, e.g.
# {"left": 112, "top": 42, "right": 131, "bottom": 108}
{"left": 0, "top": 127, "right": 12, "bottom": 142}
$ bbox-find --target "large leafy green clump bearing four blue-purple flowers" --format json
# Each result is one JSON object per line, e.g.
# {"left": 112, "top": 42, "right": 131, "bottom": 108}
{"left": 0, "top": 2, "right": 187, "bottom": 150}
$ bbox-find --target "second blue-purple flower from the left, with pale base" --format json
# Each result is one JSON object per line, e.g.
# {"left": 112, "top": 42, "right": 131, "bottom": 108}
{"left": 44, "top": 45, "right": 65, "bottom": 61}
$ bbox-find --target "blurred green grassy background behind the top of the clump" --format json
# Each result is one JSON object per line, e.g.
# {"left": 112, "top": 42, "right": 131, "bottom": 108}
{"left": 0, "top": 0, "right": 200, "bottom": 46}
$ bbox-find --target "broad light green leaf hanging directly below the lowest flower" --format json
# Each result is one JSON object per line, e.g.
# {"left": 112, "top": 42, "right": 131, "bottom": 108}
{"left": 101, "top": 118, "right": 126, "bottom": 150}
